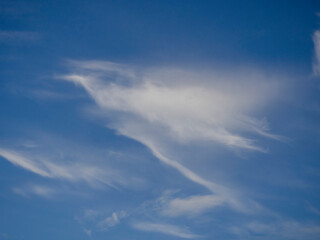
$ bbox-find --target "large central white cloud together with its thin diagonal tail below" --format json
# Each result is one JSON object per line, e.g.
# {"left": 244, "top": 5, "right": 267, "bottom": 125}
{"left": 60, "top": 61, "right": 281, "bottom": 215}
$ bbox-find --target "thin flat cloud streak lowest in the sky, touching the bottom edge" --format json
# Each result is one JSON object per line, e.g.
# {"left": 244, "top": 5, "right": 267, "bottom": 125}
{"left": 132, "top": 222, "right": 201, "bottom": 239}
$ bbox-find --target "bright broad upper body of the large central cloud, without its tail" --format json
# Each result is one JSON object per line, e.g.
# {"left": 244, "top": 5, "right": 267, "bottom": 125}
{"left": 63, "top": 63, "right": 277, "bottom": 151}
